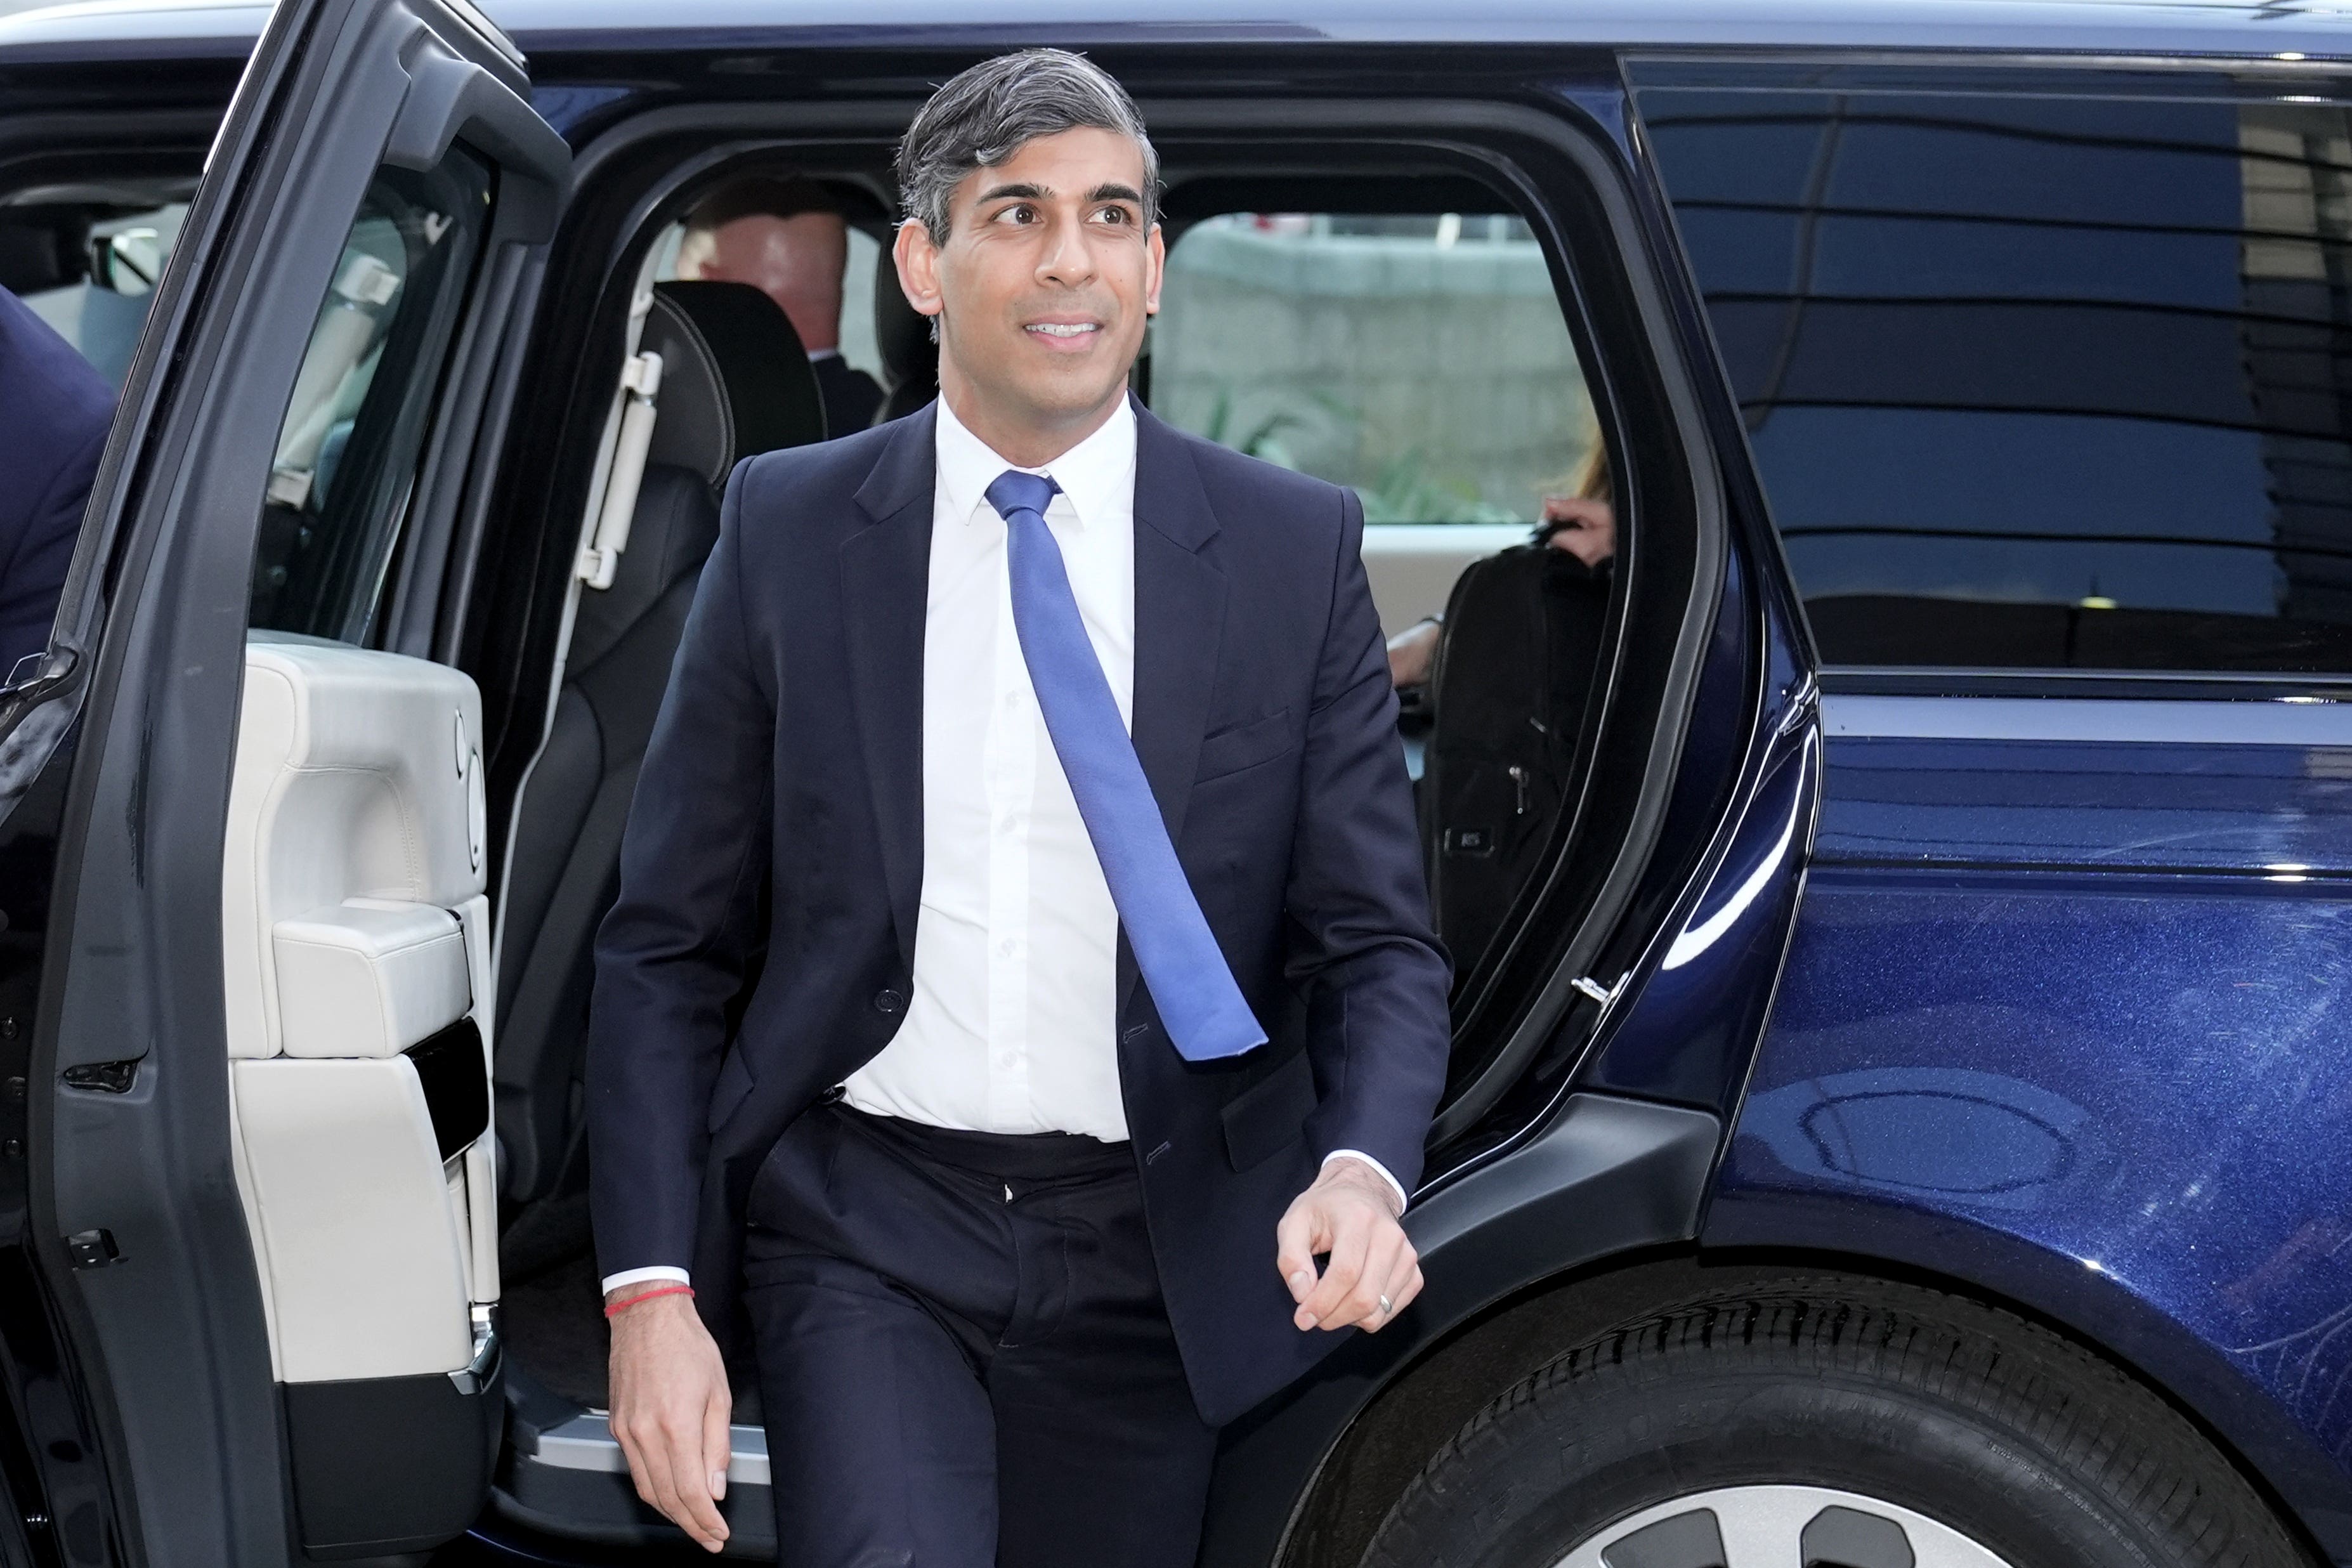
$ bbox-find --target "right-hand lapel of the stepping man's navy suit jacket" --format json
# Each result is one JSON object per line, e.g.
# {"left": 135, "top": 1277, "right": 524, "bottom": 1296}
{"left": 1120, "top": 404, "right": 1225, "bottom": 1011}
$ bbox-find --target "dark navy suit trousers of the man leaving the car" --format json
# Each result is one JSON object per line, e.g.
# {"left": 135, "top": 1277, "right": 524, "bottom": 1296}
{"left": 743, "top": 1102, "right": 1223, "bottom": 1568}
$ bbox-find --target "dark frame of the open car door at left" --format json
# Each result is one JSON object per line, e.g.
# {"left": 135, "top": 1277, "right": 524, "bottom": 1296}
{"left": 0, "top": 0, "right": 567, "bottom": 1564}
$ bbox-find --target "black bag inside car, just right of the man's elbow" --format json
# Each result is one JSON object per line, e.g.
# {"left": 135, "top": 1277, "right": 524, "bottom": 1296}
{"left": 1421, "top": 546, "right": 1611, "bottom": 976}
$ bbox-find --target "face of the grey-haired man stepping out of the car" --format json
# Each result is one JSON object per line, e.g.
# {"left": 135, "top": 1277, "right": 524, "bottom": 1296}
{"left": 898, "top": 129, "right": 1164, "bottom": 456}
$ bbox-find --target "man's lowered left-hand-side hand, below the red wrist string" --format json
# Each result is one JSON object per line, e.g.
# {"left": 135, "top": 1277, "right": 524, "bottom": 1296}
{"left": 604, "top": 1286, "right": 734, "bottom": 1552}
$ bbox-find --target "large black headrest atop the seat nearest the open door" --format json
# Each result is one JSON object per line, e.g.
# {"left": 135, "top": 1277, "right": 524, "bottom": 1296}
{"left": 637, "top": 282, "right": 826, "bottom": 489}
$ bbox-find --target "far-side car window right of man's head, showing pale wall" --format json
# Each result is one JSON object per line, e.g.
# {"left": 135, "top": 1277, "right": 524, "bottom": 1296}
{"left": 1148, "top": 212, "right": 1597, "bottom": 526}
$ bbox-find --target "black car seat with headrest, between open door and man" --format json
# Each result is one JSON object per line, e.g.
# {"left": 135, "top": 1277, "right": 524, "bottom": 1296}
{"left": 494, "top": 282, "right": 826, "bottom": 1201}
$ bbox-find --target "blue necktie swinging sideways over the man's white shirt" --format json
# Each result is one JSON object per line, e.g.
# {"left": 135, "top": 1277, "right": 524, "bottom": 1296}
{"left": 988, "top": 468, "right": 1265, "bottom": 1062}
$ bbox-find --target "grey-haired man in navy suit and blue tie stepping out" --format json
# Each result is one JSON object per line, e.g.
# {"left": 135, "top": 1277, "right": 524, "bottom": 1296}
{"left": 588, "top": 49, "right": 1449, "bottom": 1568}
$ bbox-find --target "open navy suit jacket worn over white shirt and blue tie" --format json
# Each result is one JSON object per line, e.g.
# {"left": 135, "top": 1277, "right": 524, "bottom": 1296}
{"left": 588, "top": 409, "right": 1449, "bottom": 1422}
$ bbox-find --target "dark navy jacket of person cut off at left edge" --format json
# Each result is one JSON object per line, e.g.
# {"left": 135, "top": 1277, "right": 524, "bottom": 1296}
{"left": 0, "top": 289, "right": 115, "bottom": 682}
